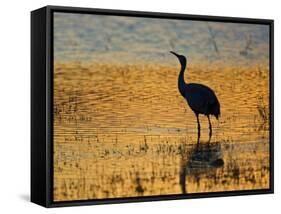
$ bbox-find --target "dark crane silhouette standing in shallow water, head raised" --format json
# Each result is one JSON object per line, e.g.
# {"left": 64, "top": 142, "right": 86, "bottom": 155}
{"left": 170, "top": 51, "right": 220, "bottom": 143}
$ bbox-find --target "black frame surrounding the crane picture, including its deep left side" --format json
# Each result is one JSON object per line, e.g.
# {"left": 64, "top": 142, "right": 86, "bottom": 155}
{"left": 31, "top": 6, "right": 274, "bottom": 207}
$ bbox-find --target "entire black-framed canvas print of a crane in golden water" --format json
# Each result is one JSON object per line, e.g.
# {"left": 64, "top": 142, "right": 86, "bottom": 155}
{"left": 31, "top": 6, "right": 273, "bottom": 207}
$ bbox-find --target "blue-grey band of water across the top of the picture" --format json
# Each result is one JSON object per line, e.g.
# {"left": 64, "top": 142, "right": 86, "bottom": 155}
{"left": 54, "top": 13, "right": 269, "bottom": 64}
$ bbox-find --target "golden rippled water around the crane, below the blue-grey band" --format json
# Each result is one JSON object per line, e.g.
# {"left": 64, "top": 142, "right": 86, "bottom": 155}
{"left": 53, "top": 59, "right": 270, "bottom": 201}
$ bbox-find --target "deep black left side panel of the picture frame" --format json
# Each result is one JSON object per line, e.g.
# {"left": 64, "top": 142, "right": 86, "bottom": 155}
{"left": 30, "top": 7, "right": 47, "bottom": 207}
